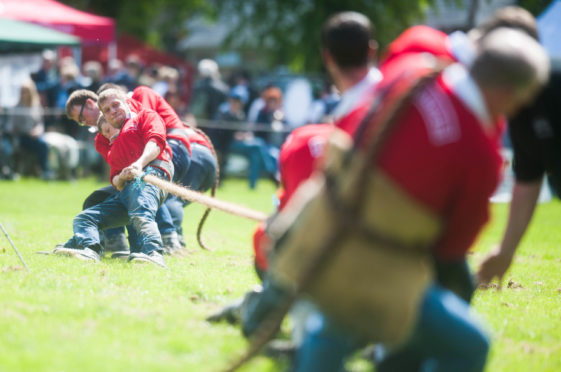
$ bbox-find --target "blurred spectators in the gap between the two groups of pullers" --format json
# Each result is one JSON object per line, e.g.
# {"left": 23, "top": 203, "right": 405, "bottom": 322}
{"left": 189, "top": 59, "right": 339, "bottom": 189}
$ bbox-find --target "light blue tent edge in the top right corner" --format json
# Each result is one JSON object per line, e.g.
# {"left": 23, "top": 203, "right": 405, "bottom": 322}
{"left": 538, "top": 0, "right": 561, "bottom": 59}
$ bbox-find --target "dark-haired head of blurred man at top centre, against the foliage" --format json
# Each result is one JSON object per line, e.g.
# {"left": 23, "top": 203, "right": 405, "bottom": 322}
{"left": 321, "top": 12, "right": 374, "bottom": 69}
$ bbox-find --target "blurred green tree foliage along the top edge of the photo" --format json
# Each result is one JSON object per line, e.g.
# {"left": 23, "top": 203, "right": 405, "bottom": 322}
{"left": 62, "top": 0, "right": 551, "bottom": 71}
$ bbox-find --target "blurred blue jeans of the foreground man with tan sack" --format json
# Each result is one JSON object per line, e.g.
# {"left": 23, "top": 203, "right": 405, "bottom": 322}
{"left": 293, "top": 285, "right": 489, "bottom": 372}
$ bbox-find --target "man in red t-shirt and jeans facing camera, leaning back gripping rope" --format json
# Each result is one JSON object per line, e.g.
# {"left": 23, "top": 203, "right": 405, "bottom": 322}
{"left": 54, "top": 89, "right": 173, "bottom": 267}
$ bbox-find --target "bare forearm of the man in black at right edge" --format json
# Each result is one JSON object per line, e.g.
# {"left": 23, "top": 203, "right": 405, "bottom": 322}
{"left": 477, "top": 179, "right": 542, "bottom": 285}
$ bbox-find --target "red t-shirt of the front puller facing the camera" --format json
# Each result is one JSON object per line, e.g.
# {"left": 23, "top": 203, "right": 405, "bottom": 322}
{"left": 106, "top": 109, "right": 171, "bottom": 182}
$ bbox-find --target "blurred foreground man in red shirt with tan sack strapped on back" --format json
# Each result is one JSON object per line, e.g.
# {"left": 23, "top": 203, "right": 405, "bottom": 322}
{"left": 245, "top": 24, "right": 549, "bottom": 371}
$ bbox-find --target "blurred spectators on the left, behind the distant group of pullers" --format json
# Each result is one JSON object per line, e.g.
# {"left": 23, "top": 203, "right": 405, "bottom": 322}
{"left": 0, "top": 50, "right": 184, "bottom": 180}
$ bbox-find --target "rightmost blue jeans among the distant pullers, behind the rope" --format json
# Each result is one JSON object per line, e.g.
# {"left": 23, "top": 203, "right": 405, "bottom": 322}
{"left": 164, "top": 143, "right": 218, "bottom": 235}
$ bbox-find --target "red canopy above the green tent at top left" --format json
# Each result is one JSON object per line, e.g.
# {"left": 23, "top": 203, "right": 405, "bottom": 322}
{"left": 0, "top": 0, "right": 115, "bottom": 45}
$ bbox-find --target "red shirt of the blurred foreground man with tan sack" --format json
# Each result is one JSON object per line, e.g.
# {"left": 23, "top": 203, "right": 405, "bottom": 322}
{"left": 337, "top": 68, "right": 501, "bottom": 259}
